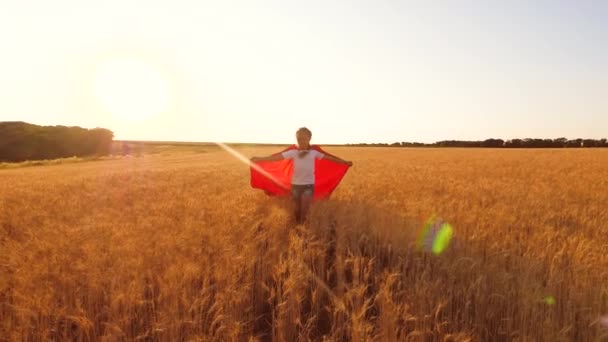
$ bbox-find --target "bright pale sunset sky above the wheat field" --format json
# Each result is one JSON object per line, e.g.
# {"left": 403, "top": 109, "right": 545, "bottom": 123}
{"left": 0, "top": 0, "right": 608, "bottom": 144}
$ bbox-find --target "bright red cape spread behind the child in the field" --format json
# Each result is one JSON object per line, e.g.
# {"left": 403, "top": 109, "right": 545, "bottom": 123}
{"left": 250, "top": 145, "right": 348, "bottom": 199}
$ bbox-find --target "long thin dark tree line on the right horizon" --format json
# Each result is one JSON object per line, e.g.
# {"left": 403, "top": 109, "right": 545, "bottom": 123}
{"left": 347, "top": 138, "right": 608, "bottom": 148}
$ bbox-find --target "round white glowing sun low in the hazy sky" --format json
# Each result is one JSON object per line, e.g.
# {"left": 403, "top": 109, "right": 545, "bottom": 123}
{"left": 94, "top": 59, "right": 169, "bottom": 123}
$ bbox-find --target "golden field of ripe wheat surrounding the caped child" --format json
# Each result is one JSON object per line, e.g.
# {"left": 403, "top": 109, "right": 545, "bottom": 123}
{"left": 0, "top": 147, "right": 608, "bottom": 341}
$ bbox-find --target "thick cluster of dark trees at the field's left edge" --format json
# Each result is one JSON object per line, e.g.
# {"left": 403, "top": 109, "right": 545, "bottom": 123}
{"left": 0, "top": 121, "right": 114, "bottom": 162}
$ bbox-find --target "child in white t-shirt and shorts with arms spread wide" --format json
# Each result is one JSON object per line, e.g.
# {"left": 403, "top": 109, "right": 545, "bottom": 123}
{"left": 251, "top": 127, "right": 353, "bottom": 224}
